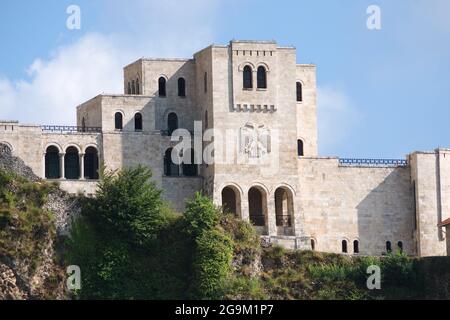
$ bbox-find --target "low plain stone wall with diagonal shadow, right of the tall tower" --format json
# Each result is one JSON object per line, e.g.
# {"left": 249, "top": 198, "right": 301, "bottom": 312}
{"left": 296, "top": 158, "right": 415, "bottom": 255}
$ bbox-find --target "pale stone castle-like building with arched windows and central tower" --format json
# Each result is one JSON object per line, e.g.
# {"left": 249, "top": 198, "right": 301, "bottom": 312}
{"left": 0, "top": 41, "right": 450, "bottom": 256}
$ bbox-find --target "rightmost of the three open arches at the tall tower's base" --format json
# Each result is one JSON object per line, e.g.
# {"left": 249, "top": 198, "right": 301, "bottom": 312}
{"left": 275, "top": 187, "right": 294, "bottom": 235}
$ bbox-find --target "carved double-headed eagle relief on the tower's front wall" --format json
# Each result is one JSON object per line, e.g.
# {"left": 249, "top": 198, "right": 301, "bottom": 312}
{"left": 240, "top": 122, "right": 271, "bottom": 158}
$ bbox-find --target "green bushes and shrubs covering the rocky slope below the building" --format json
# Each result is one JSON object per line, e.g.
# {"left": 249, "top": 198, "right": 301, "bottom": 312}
{"left": 0, "top": 167, "right": 450, "bottom": 299}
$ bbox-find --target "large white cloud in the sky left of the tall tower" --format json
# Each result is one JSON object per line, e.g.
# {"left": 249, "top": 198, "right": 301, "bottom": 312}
{"left": 0, "top": 0, "right": 216, "bottom": 124}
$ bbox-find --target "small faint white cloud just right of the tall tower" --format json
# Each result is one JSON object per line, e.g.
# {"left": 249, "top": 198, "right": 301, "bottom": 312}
{"left": 317, "top": 86, "right": 362, "bottom": 154}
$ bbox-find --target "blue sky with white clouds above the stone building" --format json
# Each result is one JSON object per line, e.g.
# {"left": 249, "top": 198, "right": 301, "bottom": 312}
{"left": 0, "top": 0, "right": 450, "bottom": 158}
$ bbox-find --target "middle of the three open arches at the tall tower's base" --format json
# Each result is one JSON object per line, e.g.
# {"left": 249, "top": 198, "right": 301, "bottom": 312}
{"left": 248, "top": 187, "right": 268, "bottom": 234}
